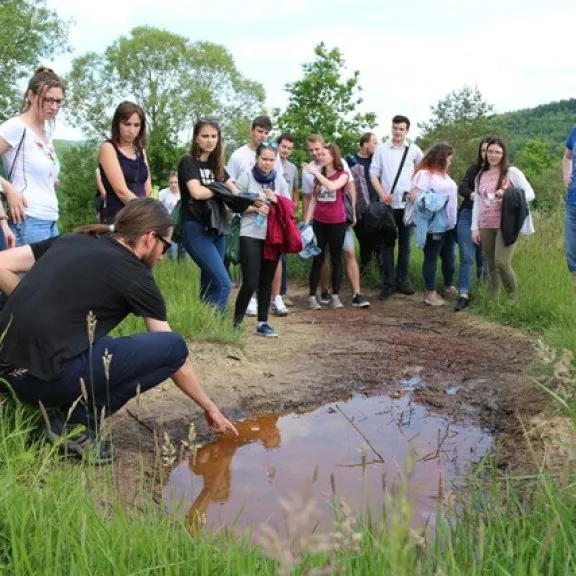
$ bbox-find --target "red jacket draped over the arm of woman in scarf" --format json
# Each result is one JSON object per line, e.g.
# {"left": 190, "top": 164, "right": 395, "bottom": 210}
{"left": 263, "top": 196, "right": 302, "bottom": 260}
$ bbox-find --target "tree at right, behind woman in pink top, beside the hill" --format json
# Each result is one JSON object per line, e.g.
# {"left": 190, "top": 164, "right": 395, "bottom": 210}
{"left": 417, "top": 86, "right": 493, "bottom": 181}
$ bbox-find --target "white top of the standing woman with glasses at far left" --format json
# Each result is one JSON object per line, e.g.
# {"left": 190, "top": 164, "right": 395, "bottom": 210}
{"left": 0, "top": 116, "right": 58, "bottom": 222}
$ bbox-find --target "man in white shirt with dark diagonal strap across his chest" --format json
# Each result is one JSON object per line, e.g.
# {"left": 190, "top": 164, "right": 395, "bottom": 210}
{"left": 370, "top": 115, "right": 423, "bottom": 300}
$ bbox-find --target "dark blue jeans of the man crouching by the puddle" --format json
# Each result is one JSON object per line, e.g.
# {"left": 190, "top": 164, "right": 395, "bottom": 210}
{"left": 6, "top": 332, "right": 188, "bottom": 430}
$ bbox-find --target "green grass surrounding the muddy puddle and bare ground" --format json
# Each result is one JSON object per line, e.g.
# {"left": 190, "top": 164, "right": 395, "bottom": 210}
{"left": 0, "top": 213, "right": 576, "bottom": 576}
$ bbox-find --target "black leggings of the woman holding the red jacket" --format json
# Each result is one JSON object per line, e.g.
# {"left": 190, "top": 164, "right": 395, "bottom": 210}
{"left": 234, "top": 236, "right": 280, "bottom": 324}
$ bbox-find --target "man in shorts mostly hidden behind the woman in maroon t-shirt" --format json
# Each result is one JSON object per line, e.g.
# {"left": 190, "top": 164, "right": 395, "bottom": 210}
{"left": 302, "top": 134, "right": 370, "bottom": 308}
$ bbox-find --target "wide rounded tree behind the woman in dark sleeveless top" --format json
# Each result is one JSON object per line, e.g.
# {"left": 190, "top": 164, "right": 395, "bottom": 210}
{"left": 68, "top": 26, "right": 265, "bottom": 179}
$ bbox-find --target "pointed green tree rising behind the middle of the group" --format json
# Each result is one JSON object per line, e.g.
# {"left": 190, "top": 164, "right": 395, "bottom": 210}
{"left": 276, "top": 42, "right": 376, "bottom": 160}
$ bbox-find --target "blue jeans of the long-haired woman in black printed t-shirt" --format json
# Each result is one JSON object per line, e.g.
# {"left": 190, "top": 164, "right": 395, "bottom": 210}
{"left": 182, "top": 219, "right": 232, "bottom": 312}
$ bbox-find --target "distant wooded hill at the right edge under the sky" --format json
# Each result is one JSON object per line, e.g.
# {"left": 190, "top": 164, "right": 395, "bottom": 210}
{"left": 490, "top": 98, "right": 576, "bottom": 156}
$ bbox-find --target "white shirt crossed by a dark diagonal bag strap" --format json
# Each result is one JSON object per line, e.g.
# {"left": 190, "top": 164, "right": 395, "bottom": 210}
{"left": 370, "top": 139, "right": 424, "bottom": 208}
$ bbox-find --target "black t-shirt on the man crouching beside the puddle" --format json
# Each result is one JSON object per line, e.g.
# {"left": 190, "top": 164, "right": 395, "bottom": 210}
{"left": 0, "top": 234, "right": 166, "bottom": 381}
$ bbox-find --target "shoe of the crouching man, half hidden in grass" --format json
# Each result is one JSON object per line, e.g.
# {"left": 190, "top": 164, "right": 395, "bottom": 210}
{"left": 45, "top": 410, "right": 118, "bottom": 464}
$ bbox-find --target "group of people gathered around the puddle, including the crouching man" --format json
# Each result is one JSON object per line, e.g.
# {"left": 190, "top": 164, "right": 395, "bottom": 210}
{"left": 0, "top": 68, "right": 560, "bottom": 461}
